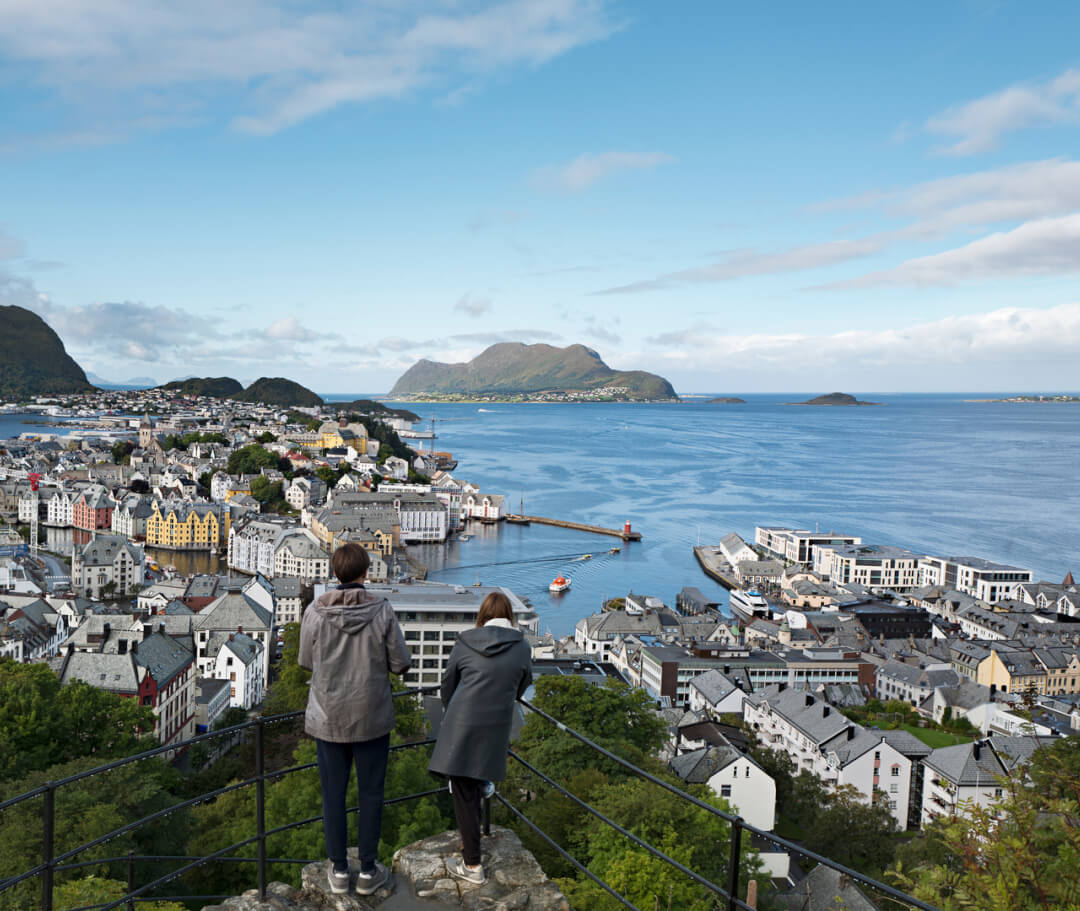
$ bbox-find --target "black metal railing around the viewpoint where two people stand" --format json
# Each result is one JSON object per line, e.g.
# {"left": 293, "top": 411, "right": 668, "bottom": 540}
{"left": 0, "top": 686, "right": 939, "bottom": 911}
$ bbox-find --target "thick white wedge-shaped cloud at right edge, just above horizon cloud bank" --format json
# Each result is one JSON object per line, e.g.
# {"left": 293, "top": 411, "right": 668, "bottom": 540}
{"left": 821, "top": 215, "right": 1080, "bottom": 289}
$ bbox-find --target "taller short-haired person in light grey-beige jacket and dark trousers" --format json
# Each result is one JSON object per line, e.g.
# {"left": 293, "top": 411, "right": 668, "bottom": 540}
{"left": 297, "top": 543, "right": 413, "bottom": 895}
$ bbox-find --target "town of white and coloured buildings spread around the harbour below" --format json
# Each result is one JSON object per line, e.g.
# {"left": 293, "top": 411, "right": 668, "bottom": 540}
{"left": 0, "top": 391, "right": 1080, "bottom": 906}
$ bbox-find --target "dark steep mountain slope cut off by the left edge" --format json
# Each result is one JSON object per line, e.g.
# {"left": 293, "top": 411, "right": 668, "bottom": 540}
{"left": 0, "top": 307, "right": 94, "bottom": 398}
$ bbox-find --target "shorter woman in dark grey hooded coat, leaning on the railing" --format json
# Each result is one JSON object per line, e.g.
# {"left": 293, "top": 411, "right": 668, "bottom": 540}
{"left": 429, "top": 592, "right": 532, "bottom": 883}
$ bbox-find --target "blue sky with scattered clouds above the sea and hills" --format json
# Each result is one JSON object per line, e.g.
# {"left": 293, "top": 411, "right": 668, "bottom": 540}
{"left": 0, "top": 0, "right": 1080, "bottom": 393}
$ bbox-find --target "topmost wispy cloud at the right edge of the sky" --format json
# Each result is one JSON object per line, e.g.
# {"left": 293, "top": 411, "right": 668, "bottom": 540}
{"left": 926, "top": 69, "right": 1080, "bottom": 155}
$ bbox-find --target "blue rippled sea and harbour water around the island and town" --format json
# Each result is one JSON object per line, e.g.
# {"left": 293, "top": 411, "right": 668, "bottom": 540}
{"left": 0, "top": 393, "right": 1080, "bottom": 636}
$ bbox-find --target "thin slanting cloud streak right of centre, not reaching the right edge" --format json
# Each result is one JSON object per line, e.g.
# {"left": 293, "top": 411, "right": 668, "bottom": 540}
{"left": 593, "top": 237, "right": 885, "bottom": 295}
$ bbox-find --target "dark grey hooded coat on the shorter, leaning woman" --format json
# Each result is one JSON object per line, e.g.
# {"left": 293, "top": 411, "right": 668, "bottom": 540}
{"left": 428, "top": 626, "right": 532, "bottom": 781}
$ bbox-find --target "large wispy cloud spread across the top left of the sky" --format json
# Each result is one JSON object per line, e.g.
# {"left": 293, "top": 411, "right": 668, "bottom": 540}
{"left": 0, "top": 0, "right": 622, "bottom": 141}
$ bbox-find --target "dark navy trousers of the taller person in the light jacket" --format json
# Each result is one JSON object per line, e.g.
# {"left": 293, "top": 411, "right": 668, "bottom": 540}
{"left": 315, "top": 734, "right": 390, "bottom": 873}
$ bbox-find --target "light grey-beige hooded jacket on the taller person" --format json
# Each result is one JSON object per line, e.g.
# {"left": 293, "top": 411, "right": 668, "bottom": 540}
{"left": 297, "top": 585, "right": 413, "bottom": 744}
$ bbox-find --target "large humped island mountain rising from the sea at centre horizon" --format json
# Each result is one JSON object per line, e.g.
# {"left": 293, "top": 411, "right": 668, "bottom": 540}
{"left": 390, "top": 342, "right": 678, "bottom": 399}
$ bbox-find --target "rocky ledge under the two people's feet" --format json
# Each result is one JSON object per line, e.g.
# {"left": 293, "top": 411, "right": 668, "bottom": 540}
{"left": 202, "top": 827, "right": 569, "bottom": 911}
